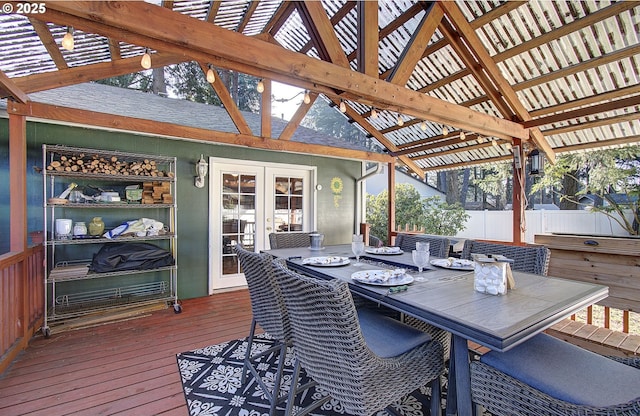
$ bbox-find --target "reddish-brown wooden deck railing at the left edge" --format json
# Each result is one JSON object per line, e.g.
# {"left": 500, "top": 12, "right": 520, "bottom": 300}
{"left": 0, "top": 245, "right": 44, "bottom": 373}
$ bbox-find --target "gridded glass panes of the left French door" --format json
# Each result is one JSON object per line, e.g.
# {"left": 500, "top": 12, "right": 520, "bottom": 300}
{"left": 220, "top": 173, "right": 256, "bottom": 275}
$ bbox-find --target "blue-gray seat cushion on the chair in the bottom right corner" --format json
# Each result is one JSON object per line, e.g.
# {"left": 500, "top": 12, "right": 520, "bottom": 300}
{"left": 480, "top": 334, "right": 640, "bottom": 407}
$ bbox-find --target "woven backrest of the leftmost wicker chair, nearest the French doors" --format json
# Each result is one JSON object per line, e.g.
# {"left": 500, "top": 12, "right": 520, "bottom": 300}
{"left": 235, "top": 244, "right": 291, "bottom": 342}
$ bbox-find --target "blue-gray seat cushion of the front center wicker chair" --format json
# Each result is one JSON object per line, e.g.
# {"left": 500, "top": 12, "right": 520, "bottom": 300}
{"left": 358, "top": 309, "right": 431, "bottom": 358}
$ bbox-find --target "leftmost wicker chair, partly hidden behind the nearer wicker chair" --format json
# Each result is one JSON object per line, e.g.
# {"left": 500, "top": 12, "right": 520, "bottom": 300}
{"left": 235, "top": 245, "right": 291, "bottom": 415}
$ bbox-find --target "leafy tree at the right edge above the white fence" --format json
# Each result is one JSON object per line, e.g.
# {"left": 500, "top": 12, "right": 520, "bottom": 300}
{"left": 533, "top": 146, "right": 640, "bottom": 235}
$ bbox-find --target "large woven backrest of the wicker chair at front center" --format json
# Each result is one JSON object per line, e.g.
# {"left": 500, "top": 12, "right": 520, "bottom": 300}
{"left": 274, "top": 262, "right": 384, "bottom": 414}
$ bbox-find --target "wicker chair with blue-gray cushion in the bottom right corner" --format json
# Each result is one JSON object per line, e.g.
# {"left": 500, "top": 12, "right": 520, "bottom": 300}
{"left": 471, "top": 334, "right": 640, "bottom": 416}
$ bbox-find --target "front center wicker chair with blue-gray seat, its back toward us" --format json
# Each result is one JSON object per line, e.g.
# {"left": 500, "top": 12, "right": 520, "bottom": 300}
{"left": 274, "top": 261, "right": 444, "bottom": 416}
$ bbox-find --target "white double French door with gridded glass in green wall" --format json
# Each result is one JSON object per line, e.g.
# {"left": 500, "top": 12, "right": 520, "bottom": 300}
{"left": 209, "top": 158, "right": 316, "bottom": 293}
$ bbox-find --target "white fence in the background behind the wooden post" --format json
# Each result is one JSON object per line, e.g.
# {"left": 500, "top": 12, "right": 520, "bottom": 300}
{"left": 456, "top": 210, "right": 633, "bottom": 243}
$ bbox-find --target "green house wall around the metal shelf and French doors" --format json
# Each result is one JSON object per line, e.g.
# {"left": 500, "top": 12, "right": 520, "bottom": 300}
{"left": 0, "top": 119, "right": 361, "bottom": 299}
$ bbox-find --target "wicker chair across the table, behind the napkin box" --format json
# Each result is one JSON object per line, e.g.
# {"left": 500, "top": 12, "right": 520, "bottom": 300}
{"left": 461, "top": 240, "right": 551, "bottom": 276}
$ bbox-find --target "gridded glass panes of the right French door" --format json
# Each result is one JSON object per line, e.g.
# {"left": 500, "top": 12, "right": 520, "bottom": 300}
{"left": 273, "top": 176, "right": 304, "bottom": 232}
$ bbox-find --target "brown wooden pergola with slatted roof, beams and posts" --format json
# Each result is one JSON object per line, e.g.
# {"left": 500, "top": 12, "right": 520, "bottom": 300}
{"left": 0, "top": 0, "right": 640, "bottom": 244}
